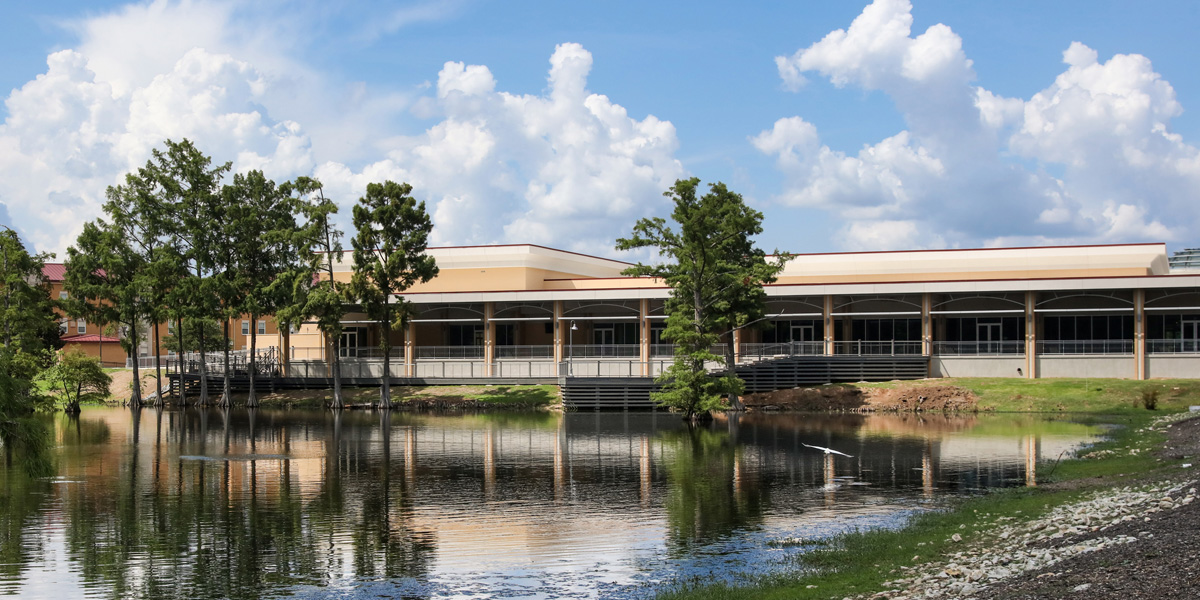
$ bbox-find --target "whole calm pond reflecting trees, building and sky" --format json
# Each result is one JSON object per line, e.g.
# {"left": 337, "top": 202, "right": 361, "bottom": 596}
{"left": 0, "top": 409, "right": 1103, "bottom": 600}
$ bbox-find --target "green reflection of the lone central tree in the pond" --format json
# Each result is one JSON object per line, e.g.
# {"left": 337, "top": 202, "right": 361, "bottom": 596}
{"left": 660, "top": 427, "right": 768, "bottom": 554}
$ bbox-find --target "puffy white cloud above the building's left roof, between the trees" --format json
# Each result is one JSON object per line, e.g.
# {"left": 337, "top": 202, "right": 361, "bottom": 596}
{"left": 318, "top": 43, "right": 684, "bottom": 254}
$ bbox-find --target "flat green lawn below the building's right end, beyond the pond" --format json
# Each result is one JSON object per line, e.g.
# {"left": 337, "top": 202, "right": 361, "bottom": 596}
{"left": 858, "top": 377, "right": 1200, "bottom": 414}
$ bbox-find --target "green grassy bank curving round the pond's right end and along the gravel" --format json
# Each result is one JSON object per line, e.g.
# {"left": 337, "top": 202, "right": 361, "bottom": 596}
{"left": 659, "top": 379, "right": 1200, "bottom": 600}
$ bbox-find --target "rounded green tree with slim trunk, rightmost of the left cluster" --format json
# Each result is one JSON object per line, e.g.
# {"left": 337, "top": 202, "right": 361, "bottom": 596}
{"left": 350, "top": 181, "right": 438, "bottom": 404}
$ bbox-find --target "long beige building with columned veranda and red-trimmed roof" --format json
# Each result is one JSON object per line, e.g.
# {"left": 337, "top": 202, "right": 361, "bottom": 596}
{"left": 259, "top": 244, "right": 1200, "bottom": 379}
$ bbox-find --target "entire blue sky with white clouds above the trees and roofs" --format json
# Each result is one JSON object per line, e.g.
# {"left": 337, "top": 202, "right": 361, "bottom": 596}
{"left": 0, "top": 0, "right": 1200, "bottom": 257}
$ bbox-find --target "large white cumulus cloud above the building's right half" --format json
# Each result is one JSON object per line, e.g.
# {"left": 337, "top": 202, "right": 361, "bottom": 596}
{"left": 751, "top": 0, "right": 1200, "bottom": 250}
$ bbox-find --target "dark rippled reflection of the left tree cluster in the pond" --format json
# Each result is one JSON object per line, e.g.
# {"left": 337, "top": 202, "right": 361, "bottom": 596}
{"left": 51, "top": 405, "right": 434, "bottom": 600}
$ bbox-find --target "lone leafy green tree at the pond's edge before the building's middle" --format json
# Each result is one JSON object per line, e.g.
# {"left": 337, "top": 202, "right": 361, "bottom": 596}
{"left": 617, "top": 178, "right": 787, "bottom": 418}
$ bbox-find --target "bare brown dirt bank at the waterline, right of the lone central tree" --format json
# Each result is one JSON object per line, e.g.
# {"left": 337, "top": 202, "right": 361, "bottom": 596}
{"left": 742, "top": 384, "right": 979, "bottom": 413}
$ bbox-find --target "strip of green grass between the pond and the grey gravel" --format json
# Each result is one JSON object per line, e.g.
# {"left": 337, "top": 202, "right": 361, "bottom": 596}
{"left": 658, "top": 396, "right": 1180, "bottom": 600}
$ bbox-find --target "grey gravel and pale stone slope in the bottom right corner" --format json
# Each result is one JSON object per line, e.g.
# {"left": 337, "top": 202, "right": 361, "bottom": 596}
{"left": 854, "top": 414, "right": 1200, "bottom": 600}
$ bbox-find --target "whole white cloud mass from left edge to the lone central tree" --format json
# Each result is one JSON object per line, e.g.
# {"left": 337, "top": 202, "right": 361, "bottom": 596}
{"left": 0, "top": 0, "right": 684, "bottom": 260}
